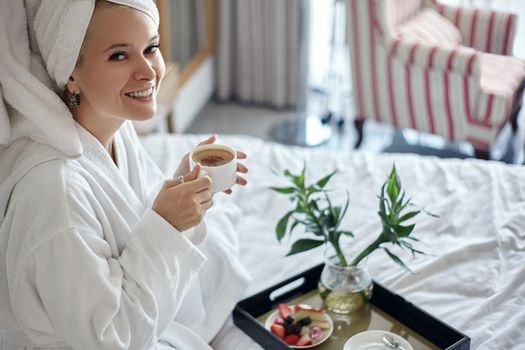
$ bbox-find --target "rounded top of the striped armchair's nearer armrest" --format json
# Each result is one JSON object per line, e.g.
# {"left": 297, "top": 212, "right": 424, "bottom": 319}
{"left": 389, "top": 39, "right": 480, "bottom": 77}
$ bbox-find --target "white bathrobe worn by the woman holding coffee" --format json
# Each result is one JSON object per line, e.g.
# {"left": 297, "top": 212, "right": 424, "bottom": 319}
{"left": 0, "top": 122, "right": 252, "bottom": 350}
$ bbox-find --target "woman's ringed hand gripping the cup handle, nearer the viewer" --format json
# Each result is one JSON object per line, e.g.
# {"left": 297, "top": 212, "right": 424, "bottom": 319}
{"left": 153, "top": 164, "right": 213, "bottom": 232}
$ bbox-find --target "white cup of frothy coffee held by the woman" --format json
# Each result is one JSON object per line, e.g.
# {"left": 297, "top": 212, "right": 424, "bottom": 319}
{"left": 190, "top": 144, "right": 237, "bottom": 193}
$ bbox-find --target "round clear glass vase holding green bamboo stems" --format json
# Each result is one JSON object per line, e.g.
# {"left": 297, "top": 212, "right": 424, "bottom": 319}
{"left": 319, "top": 249, "right": 373, "bottom": 314}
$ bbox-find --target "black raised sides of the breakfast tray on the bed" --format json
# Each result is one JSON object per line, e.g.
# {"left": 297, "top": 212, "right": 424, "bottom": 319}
{"left": 233, "top": 264, "right": 470, "bottom": 350}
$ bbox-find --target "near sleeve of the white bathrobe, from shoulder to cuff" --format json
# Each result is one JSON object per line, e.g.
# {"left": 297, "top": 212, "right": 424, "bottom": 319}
{"left": 2, "top": 157, "right": 206, "bottom": 350}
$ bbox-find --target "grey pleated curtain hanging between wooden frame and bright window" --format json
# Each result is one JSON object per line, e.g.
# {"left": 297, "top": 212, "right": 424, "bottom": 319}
{"left": 217, "top": 0, "right": 309, "bottom": 109}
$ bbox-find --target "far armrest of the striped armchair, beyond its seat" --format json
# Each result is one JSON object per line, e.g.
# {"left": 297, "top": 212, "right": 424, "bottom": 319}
{"left": 430, "top": 0, "right": 517, "bottom": 55}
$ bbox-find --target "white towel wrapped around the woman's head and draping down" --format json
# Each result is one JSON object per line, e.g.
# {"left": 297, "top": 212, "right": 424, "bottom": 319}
{"left": 0, "top": 0, "right": 159, "bottom": 216}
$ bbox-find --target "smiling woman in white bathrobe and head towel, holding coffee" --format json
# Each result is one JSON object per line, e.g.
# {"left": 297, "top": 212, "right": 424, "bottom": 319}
{"left": 0, "top": 0, "right": 252, "bottom": 350}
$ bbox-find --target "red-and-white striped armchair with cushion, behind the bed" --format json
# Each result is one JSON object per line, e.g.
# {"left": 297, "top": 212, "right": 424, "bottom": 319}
{"left": 348, "top": 0, "right": 525, "bottom": 158}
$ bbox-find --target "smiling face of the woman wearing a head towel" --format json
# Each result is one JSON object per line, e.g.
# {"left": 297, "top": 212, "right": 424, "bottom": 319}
{"left": 67, "top": 6, "right": 165, "bottom": 125}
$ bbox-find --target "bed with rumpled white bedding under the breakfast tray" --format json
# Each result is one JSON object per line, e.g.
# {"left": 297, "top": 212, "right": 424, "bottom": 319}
{"left": 142, "top": 135, "right": 525, "bottom": 349}
